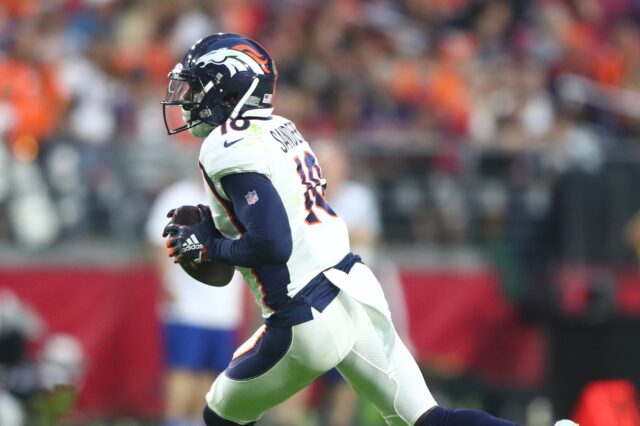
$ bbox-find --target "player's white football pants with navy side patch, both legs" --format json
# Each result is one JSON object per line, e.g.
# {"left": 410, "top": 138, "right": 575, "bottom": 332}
{"left": 206, "top": 263, "right": 436, "bottom": 425}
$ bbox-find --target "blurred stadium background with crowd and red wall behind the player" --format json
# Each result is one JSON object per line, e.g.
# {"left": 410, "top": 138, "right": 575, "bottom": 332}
{"left": 0, "top": 0, "right": 640, "bottom": 426}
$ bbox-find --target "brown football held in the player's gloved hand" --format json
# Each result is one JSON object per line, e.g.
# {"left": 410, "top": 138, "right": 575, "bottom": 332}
{"left": 172, "top": 206, "right": 235, "bottom": 287}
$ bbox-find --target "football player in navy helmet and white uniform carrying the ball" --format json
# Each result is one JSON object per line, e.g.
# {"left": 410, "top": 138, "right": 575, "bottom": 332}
{"left": 163, "top": 34, "right": 580, "bottom": 426}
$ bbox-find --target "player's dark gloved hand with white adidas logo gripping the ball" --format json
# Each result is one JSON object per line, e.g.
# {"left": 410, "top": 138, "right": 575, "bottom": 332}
{"left": 162, "top": 204, "right": 222, "bottom": 263}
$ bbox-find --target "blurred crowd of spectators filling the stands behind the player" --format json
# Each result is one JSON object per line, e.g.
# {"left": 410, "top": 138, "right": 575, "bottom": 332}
{"left": 0, "top": 0, "right": 640, "bottom": 247}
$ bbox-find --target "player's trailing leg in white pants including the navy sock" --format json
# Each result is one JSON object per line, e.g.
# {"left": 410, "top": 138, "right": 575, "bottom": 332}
{"left": 338, "top": 265, "right": 515, "bottom": 426}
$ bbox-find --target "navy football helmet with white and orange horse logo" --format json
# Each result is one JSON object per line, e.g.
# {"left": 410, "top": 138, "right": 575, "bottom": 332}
{"left": 162, "top": 33, "right": 278, "bottom": 135}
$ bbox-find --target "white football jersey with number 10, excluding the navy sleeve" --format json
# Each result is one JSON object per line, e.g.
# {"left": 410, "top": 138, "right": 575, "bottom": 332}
{"left": 200, "top": 111, "right": 350, "bottom": 317}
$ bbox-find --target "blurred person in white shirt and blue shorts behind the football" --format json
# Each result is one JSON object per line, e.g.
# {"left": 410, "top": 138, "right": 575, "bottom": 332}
{"left": 147, "top": 178, "right": 242, "bottom": 426}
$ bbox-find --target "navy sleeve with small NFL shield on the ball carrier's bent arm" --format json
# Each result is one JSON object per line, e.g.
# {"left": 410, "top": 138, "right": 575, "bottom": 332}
{"left": 210, "top": 173, "right": 293, "bottom": 267}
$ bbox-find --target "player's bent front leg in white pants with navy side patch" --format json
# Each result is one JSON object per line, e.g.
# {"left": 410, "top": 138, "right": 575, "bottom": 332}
{"left": 205, "top": 303, "right": 355, "bottom": 426}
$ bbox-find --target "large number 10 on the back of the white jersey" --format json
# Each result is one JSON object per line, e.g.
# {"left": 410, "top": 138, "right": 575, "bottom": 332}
{"left": 293, "top": 151, "right": 337, "bottom": 225}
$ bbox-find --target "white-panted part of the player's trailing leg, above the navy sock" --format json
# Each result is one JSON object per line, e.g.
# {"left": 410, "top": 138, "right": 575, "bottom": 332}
{"left": 329, "top": 264, "right": 436, "bottom": 425}
